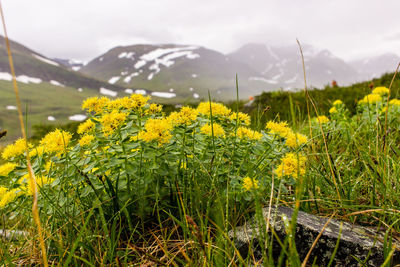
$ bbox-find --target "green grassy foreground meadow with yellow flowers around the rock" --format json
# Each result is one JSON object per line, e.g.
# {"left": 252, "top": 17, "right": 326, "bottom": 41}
{"left": 0, "top": 70, "right": 400, "bottom": 266}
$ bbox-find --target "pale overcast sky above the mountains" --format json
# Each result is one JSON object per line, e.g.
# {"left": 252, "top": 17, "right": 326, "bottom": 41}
{"left": 2, "top": 0, "right": 400, "bottom": 60}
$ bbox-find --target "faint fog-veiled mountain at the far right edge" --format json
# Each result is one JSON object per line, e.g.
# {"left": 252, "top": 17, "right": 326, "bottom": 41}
{"left": 349, "top": 53, "right": 400, "bottom": 79}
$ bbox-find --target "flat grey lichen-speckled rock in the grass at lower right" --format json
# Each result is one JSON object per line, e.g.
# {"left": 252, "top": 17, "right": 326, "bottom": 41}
{"left": 229, "top": 206, "right": 400, "bottom": 266}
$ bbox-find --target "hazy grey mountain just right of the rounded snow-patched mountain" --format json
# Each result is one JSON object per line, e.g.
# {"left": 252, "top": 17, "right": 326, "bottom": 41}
{"left": 228, "top": 44, "right": 361, "bottom": 90}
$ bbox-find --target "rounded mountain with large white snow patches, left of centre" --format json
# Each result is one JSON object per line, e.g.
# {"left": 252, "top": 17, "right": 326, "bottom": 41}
{"left": 80, "top": 44, "right": 259, "bottom": 100}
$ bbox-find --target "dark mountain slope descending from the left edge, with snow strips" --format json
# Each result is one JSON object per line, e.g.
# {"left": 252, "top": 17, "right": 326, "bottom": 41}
{"left": 0, "top": 36, "right": 124, "bottom": 93}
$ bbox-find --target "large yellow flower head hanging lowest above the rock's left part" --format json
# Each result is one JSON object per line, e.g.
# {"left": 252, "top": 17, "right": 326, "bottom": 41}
{"left": 275, "top": 152, "right": 306, "bottom": 178}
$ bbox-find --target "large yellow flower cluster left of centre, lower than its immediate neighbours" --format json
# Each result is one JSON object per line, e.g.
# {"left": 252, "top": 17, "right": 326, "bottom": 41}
{"left": 137, "top": 119, "right": 172, "bottom": 145}
